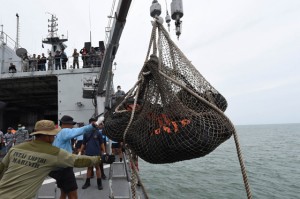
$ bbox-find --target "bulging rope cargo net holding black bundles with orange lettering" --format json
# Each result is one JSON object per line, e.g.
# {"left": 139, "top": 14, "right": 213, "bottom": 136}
{"left": 104, "top": 22, "right": 234, "bottom": 164}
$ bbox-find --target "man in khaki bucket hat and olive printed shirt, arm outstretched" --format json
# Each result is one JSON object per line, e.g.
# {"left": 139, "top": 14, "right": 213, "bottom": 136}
{"left": 0, "top": 120, "right": 101, "bottom": 199}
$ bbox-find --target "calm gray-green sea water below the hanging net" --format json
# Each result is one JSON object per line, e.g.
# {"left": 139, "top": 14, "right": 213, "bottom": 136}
{"left": 139, "top": 124, "right": 300, "bottom": 199}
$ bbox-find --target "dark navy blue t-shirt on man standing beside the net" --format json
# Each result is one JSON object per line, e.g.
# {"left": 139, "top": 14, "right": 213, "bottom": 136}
{"left": 82, "top": 130, "right": 103, "bottom": 156}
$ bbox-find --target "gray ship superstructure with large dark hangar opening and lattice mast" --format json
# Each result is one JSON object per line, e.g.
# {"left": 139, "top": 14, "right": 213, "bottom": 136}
{"left": 0, "top": 15, "right": 100, "bottom": 131}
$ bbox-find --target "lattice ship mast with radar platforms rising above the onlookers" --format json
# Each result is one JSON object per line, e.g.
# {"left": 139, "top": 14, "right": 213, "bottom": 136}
{"left": 42, "top": 13, "right": 68, "bottom": 55}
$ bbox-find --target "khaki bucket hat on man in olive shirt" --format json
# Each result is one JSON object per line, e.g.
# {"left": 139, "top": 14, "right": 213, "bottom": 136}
{"left": 30, "top": 120, "right": 61, "bottom": 135}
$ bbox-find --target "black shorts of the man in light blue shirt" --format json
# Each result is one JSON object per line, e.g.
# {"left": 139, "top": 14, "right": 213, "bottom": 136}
{"left": 49, "top": 167, "right": 78, "bottom": 193}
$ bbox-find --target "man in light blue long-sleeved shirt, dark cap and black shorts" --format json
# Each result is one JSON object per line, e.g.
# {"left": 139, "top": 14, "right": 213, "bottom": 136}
{"left": 49, "top": 115, "right": 97, "bottom": 199}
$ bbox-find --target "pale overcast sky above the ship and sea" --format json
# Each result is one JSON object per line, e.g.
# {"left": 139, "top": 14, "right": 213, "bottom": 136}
{"left": 0, "top": 0, "right": 300, "bottom": 125}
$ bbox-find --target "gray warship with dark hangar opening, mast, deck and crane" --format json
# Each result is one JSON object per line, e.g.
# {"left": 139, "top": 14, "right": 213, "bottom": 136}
{"left": 0, "top": 0, "right": 251, "bottom": 199}
